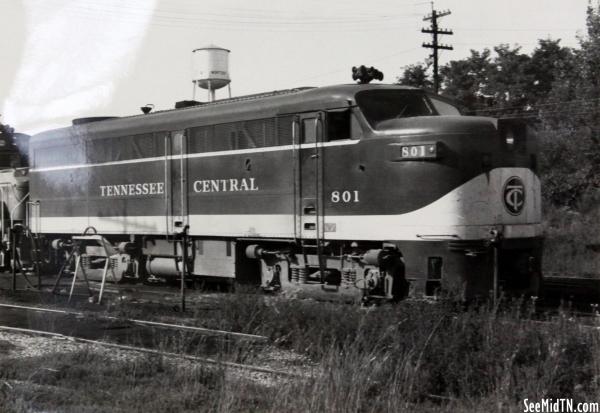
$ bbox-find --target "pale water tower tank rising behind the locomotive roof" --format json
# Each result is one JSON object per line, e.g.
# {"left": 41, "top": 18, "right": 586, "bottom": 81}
{"left": 192, "top": 45, "right": 231, "bottom": 102}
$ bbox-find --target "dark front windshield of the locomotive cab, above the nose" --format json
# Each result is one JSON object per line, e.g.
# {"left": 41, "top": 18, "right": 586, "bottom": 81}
{"left": 356, "top": 89, "right": 437, "bottom": 129}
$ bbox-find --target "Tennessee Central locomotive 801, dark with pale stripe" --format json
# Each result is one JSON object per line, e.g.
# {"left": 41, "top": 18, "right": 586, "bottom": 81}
{"left": 14, "top": 85, "right": 542, "bottom": 299}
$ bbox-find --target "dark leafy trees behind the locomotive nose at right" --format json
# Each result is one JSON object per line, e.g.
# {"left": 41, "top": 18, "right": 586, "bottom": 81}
{"left": 398, "top": 5, "right": 600, "bottom": 208}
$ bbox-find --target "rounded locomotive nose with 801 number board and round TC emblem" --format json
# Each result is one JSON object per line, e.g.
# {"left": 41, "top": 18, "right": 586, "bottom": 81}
{"left": 382, "top": 116, "right": 541, "bottom": 238}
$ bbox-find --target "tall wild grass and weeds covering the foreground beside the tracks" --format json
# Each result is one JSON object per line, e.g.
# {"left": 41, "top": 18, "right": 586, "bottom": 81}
{"left": 0, "top": 294, "right": 600, "bottom": 412}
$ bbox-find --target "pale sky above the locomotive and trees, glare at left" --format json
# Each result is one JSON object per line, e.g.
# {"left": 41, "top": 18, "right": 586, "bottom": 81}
{"left": 0, "top": 0, "right": 597, "bottom": 133}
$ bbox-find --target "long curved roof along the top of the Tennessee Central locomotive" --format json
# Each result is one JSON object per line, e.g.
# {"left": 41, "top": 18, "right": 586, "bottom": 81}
{"left": 32, "top": 84, "right": 418, "bottom": 142}
